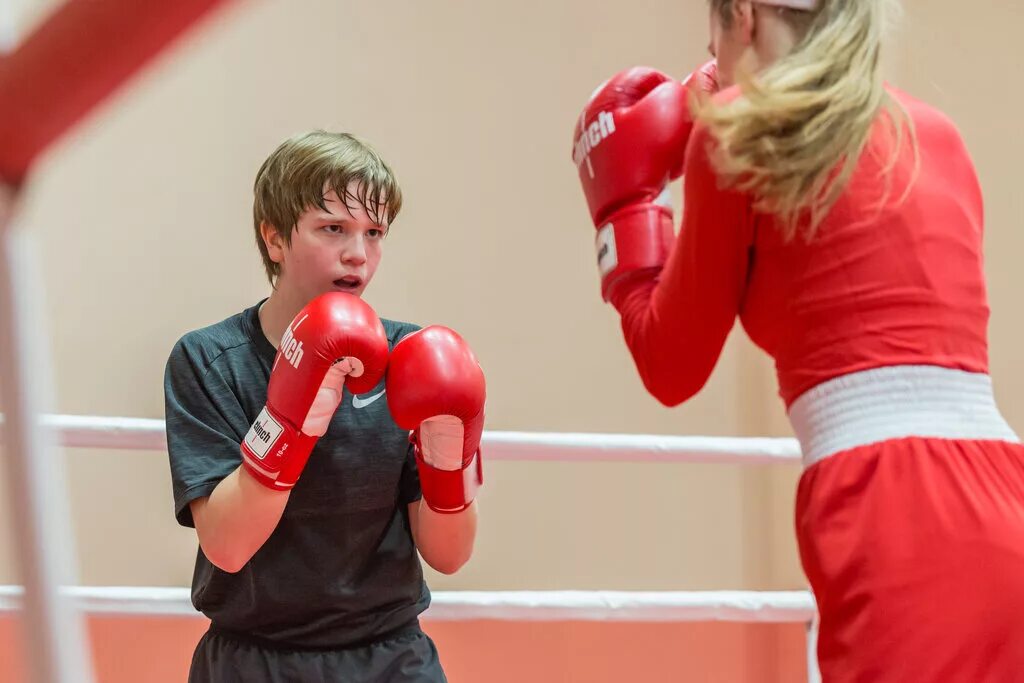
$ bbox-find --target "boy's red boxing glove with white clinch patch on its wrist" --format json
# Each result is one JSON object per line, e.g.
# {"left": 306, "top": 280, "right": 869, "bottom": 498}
{"left": 242, "top": 292, "right": 388, "bottom": 490}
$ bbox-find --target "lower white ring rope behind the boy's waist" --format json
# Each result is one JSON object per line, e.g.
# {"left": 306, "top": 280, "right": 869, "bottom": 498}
{"left": 0, "top": 586, "right": 814, "bottom": 624}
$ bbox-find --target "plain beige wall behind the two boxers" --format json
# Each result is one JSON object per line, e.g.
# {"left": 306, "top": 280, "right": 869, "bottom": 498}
{"left": 0, "top": 0, "right": 1024, "bottom": 589}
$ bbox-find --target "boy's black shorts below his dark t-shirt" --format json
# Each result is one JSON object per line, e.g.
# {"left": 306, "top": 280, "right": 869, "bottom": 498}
{"left": 188, "top": 626, "right": 447, "bottom": 683}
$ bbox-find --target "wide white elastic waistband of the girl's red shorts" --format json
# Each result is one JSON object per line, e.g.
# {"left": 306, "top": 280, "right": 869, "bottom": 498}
{"left": 790, "top": 366, "right": 1019, "bottom": 467}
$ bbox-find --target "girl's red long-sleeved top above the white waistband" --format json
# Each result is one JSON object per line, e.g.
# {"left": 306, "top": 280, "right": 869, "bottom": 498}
{"left": 612, "top": 90, "right": 989, "bottom": 407}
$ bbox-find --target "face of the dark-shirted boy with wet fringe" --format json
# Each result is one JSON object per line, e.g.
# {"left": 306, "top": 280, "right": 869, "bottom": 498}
{"left": 264, "top": 181, "right": 387, "bottom": 301}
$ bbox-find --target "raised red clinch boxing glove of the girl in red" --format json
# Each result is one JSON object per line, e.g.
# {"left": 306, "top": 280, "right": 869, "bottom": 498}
{"left": 572, "top": 61, "right": 718, "bottom": 301}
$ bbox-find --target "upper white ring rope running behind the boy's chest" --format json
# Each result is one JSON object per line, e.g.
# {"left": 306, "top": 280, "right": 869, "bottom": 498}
{"left": 0, "top": 415, "right": 800, "bottom": 464}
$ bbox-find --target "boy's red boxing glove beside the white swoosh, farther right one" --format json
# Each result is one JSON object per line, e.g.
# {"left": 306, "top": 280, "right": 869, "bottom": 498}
{"left": 387, "top": 326, "right": 486, "bottom": 512}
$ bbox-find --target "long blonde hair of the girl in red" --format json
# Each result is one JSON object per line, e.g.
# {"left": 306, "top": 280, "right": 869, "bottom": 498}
{"left": 699, "top": 0, "right": 916, "bottom": 240}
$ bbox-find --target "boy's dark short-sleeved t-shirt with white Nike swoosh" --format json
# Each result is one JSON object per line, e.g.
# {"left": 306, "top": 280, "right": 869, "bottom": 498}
{"left": 164, "top": 302, "right": 430, "bottom": 647}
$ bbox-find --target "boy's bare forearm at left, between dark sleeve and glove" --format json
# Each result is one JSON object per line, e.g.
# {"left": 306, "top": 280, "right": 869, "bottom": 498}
{"left": 191, "top": 467, "right": 291, "bottom": 572}
